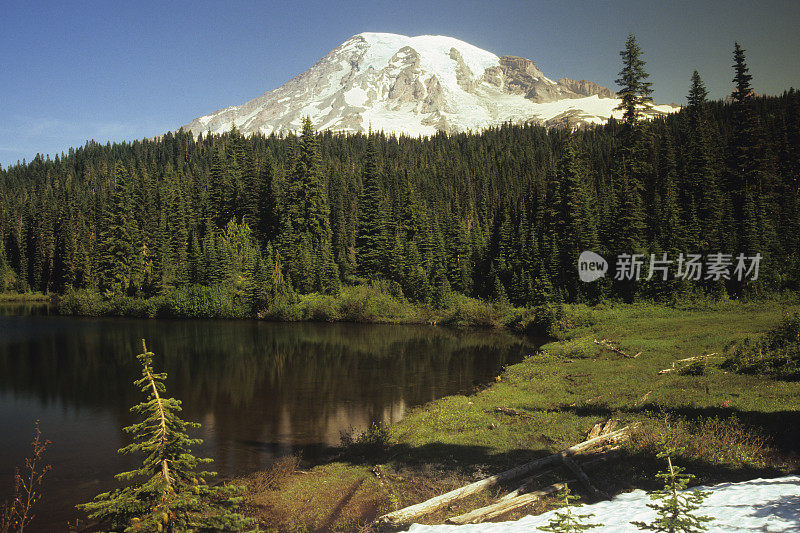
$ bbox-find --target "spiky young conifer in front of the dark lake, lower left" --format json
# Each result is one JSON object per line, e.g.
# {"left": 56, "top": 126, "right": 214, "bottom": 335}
{"left": 78, "top": 339, "right": 257, "bottom": 532}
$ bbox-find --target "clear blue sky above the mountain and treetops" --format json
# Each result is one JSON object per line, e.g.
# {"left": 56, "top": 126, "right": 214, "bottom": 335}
{"left": 0, "top": 0, "right": 800, "bottom": 167}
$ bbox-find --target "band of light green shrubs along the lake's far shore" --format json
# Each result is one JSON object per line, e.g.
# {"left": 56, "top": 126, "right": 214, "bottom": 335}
{"left": 53, "top": 281, "right": 567, "bottom": 335}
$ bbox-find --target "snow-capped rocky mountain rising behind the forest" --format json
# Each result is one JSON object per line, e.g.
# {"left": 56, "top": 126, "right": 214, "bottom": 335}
{"left": 183, "top": 33, "right": 676, "bottom": 136}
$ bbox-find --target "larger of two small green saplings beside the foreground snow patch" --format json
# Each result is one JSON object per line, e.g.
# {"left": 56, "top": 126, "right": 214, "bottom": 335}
{"left": 631, "top": 446, "right": 713, "bottom": 533}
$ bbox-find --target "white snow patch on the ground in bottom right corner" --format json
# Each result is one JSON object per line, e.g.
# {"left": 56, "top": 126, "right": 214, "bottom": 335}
{"left": 408, "top": 476, "right": 800, "bottom": 533}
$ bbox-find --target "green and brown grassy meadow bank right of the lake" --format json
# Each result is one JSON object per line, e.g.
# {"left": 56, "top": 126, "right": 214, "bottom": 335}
{"left": 231, "top": 301, "right": 800, "bottom": 531}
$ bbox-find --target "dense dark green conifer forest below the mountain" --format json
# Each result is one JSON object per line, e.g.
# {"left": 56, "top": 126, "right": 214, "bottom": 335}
{"left": 0, "top": 38, "right": 800, "bottom": 312}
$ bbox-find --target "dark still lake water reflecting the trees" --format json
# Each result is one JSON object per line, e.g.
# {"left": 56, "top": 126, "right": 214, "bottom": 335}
{"left": 0, "top": 304, "right": 535, "bottom": 531}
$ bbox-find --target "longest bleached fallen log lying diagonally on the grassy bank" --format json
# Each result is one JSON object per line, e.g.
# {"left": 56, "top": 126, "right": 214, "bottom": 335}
{"left": 377, "top": 426, "right": 631, "bottom": 525}
